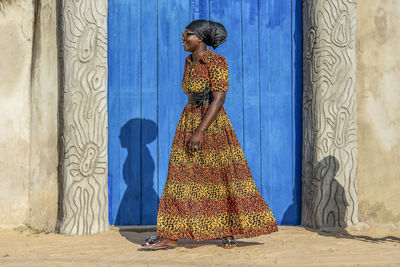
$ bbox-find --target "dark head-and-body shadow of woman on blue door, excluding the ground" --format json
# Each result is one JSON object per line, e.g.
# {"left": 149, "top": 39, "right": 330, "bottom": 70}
{"left": 115, "top": 118, "right": 159, "bottom": 225}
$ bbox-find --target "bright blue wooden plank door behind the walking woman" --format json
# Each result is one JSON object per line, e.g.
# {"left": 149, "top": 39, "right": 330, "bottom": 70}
{"left": 108, "top": 0, "right": 302, "bottom": 225}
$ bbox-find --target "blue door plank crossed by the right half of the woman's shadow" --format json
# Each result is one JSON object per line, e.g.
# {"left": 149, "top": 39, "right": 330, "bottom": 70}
{"left": 140, "top": 0, "right": 159, "bottom": 225}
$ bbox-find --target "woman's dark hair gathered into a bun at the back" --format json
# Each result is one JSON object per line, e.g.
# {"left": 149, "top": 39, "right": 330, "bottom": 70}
{"left": 186, "top": 19, "right": 227, "bottom": 49}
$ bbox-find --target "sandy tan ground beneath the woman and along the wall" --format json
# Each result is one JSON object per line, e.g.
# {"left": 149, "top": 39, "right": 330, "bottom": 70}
{"left": 0, "top": 226, "right": 400, "bottom": 266}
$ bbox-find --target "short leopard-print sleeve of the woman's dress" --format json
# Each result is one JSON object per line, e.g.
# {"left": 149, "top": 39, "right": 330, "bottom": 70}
{"left": 209, "top": 55, "right": 229, "bottom": 92}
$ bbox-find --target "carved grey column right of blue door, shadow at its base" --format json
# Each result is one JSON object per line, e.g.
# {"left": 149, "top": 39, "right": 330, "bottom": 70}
{"left": 302, "top": 0, "right": 358, "bottom": 228}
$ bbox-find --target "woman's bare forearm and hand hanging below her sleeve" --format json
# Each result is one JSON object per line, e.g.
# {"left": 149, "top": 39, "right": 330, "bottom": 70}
{"left": 188, "top": 92, "right": 226, "bottom": 152}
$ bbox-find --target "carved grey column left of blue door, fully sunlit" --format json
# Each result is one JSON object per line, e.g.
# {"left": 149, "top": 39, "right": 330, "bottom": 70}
{"left": 57, "top": 0, "right": 109, "bottom": 235}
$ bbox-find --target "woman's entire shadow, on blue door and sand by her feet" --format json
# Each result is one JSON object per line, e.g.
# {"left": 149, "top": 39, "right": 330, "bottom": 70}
{"left": 115, "top": 118, "right": 263, "bottom": 248}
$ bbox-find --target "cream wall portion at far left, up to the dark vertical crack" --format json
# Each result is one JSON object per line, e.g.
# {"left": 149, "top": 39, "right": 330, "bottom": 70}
{"left": 0, "top": 0, "right": 33, "bottom": 228}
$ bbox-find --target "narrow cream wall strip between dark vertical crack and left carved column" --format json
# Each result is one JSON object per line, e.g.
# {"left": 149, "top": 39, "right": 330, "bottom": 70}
{"left": 27, "top": 0, "right": 58, "bottom": 231}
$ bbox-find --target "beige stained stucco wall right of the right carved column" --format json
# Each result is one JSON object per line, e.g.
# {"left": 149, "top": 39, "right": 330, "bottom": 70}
{"left": 357, "top": 0, "right": 400, "bottom": 228}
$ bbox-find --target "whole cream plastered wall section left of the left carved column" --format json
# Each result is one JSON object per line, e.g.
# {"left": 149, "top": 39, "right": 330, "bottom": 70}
{"left": 0, "top": 0, "right": 58, "bottom": 231}
